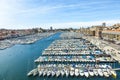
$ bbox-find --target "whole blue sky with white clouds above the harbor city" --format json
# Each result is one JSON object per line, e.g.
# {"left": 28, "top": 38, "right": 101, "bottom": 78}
{"left": 0, "top": 0, "right": 120, "bottom": 29}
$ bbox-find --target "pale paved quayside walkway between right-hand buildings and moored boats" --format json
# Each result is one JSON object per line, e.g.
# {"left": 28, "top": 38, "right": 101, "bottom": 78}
{"left": 83, "top": 36, "right": 120, "bottom": 62}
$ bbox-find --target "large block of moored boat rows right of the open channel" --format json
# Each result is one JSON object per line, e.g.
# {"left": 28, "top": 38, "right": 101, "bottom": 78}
{"left": 27, "top": 33, "right": 117, "bottom": 78}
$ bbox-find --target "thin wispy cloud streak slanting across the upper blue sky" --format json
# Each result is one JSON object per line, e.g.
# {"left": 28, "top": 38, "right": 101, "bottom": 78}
{"left": 16, "top": 0, "right": 108, "bottom": 13}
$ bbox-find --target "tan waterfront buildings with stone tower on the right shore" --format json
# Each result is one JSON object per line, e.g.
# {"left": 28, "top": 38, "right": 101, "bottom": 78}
{"left": 78, "top": 23, "right": 120, "bottom": 44}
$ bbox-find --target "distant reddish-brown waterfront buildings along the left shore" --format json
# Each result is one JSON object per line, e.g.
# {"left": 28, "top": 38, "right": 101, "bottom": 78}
{"left": 0, "top": 28, "right": 43, "bottom": 40}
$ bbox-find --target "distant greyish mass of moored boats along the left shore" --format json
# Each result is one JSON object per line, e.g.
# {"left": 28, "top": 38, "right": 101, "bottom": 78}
{"left": 0, "top": 33, "right": 54, "bottom": 50}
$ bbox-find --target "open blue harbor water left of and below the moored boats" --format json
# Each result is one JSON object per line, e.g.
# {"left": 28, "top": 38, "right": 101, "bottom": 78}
{"left": 0, "top": 33, "right": 120, "bottom": 80}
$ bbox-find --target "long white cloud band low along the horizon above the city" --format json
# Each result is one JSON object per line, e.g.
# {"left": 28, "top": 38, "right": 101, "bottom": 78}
{"left": 5, "top": 20, "right": 120, "bottom": 29}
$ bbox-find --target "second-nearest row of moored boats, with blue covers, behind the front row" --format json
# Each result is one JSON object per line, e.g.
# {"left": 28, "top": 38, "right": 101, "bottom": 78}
{"left": 34, "top": 56, "right": 114, "bottom": 62}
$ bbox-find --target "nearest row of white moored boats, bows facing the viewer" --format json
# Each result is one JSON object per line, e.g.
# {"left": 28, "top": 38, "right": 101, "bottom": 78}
{"left": 27, "top": 64, "right": 117, "bottom": 77}
